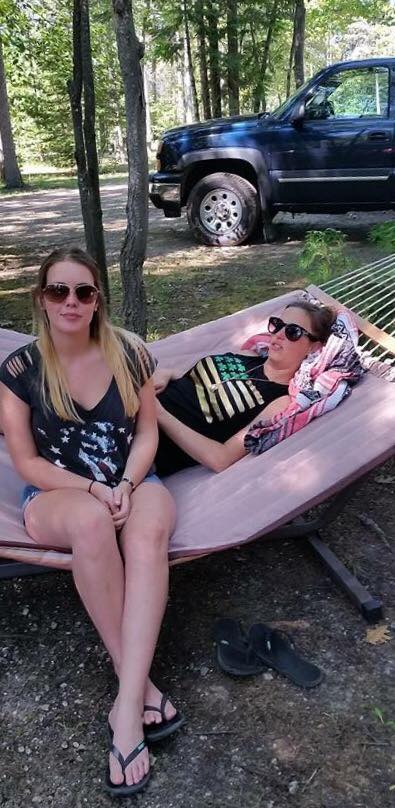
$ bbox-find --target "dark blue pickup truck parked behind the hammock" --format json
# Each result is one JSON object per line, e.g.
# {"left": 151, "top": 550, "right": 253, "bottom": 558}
{"left": 150, "top": 58, "right": 395, "bottom": 246}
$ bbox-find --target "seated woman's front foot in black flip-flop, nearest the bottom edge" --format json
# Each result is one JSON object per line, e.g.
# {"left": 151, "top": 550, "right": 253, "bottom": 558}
{"left": 109, "top": 703, "right": 149, "bottom": 786}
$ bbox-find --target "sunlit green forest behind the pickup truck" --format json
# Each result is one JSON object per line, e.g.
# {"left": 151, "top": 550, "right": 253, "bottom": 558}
{"left": 0, "top": 0, "right": 395, "bottom": 173}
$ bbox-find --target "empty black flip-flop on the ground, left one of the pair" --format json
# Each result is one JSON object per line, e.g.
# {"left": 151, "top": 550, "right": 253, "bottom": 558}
{"left": 214, "top": 617, "right": 266, "bottom": 676}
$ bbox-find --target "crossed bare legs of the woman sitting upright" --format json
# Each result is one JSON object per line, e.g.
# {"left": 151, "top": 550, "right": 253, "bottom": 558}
{"left": 25, "top": 482, "right": 175, "bottom": 784}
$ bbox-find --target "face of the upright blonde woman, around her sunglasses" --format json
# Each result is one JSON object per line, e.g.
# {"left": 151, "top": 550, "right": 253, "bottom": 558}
{"left": 41, "top": 259, "right": 98, "bottom": 334}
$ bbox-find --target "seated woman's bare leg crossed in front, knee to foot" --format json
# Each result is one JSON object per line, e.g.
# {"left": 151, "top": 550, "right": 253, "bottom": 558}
{"left": 110, "top": 482, "right": 175, "bottom": 784}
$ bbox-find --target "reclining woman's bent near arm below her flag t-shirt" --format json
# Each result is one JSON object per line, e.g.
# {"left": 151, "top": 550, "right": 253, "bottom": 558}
{"left": 156, "top": 396, "right": 289, "bottom": 472}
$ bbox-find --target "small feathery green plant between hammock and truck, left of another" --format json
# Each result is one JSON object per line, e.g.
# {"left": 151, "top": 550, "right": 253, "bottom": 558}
{"left": 299, "top": 227, "right": 348, "bottom": 283}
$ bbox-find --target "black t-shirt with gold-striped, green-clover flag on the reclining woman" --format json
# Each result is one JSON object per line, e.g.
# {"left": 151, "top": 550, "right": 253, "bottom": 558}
{"left": 155, "top": 352, "right": 288, "bottom": 476}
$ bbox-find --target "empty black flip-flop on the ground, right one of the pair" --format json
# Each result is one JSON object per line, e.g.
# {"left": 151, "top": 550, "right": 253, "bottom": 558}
{"left": 248, "top": 623, "right": 324, "bottom": 688}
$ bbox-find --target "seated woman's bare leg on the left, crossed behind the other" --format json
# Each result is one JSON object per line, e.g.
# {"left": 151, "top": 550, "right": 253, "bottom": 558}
{"left": 25, "top": 489, "right": 124, "bottom": 674}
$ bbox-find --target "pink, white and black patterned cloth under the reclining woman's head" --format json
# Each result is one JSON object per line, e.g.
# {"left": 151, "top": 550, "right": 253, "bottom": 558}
{"left": 242, "top": 311, "right": 363, "bottom": 454}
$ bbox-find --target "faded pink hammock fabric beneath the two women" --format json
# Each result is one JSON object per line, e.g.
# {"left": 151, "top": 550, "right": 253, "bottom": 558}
{"left": 0, "top": 292, "right": 395, "bottom": 569}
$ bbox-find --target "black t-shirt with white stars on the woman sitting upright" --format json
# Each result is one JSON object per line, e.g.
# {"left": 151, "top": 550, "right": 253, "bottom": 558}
{"left": 0, "top": 342, "right": 155, "bottom": 486}
